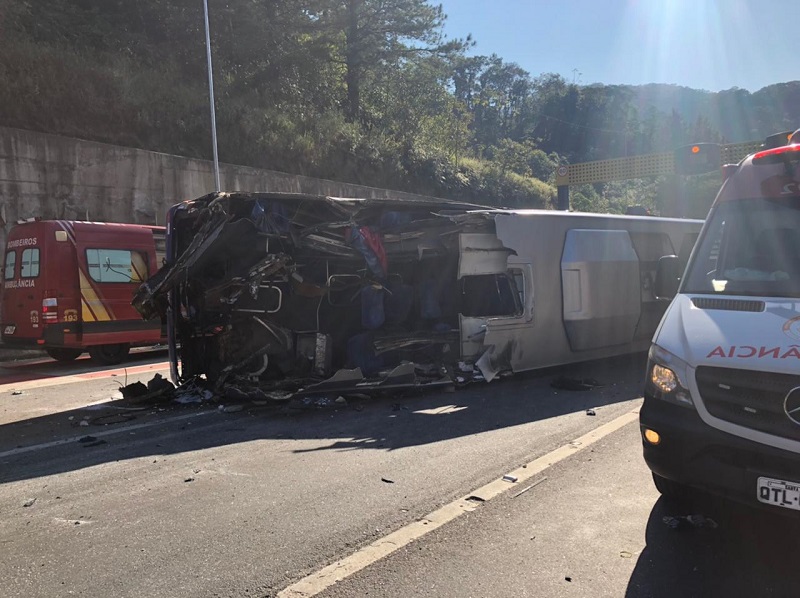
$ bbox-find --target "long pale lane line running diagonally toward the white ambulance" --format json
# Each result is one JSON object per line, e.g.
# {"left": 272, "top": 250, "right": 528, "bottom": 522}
{"left": 277, "top": 407, "right": 639, "bottom": 598}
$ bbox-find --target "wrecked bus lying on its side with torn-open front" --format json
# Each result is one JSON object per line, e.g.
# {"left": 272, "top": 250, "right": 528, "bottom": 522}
{"left": 134, "top": 193, "right": 702, "bottom": 399}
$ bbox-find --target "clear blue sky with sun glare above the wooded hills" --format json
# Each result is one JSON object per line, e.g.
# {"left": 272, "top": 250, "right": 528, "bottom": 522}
{"left": 438, "top": 0, "right": 800, "bottom": 92}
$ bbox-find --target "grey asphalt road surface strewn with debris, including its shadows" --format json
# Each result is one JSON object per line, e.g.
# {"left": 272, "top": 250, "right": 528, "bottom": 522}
{"left": 0, "top": 356, "right": 800, "bottom": 597}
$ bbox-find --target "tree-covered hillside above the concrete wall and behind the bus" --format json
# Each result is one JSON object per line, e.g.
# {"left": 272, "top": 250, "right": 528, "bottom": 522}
{"left": 0, "top": 0, "right": 800, "bottom": 216}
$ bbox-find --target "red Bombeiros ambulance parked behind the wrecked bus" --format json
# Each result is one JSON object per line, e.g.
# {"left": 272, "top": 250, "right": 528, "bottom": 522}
{"left": 0, "top": 219, "right": 165, "bottom": 364}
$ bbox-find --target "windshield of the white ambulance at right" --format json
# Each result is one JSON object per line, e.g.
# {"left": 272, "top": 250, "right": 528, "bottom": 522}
{"left": 682, "top": 197, "right": 800, "bottom": 298}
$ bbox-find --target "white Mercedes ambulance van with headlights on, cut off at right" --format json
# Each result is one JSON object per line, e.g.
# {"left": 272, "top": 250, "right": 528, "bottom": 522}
{"left": 640, "top": 133, "right": 800, "bottom": 515}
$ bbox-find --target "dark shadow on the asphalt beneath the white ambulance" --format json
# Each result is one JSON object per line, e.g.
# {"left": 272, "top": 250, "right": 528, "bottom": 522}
{"left": 625, "top": 496, "right": 800, "bottom": 598}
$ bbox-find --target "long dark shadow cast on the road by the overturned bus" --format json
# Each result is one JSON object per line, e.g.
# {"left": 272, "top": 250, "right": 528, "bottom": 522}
{"left": 0, "top": 355, "right": 646, "bottom": 483}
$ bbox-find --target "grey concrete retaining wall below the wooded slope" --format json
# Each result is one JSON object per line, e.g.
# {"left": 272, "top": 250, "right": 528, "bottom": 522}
{"left": 0, "top": 127, "right": 440, "bottom": 240}
